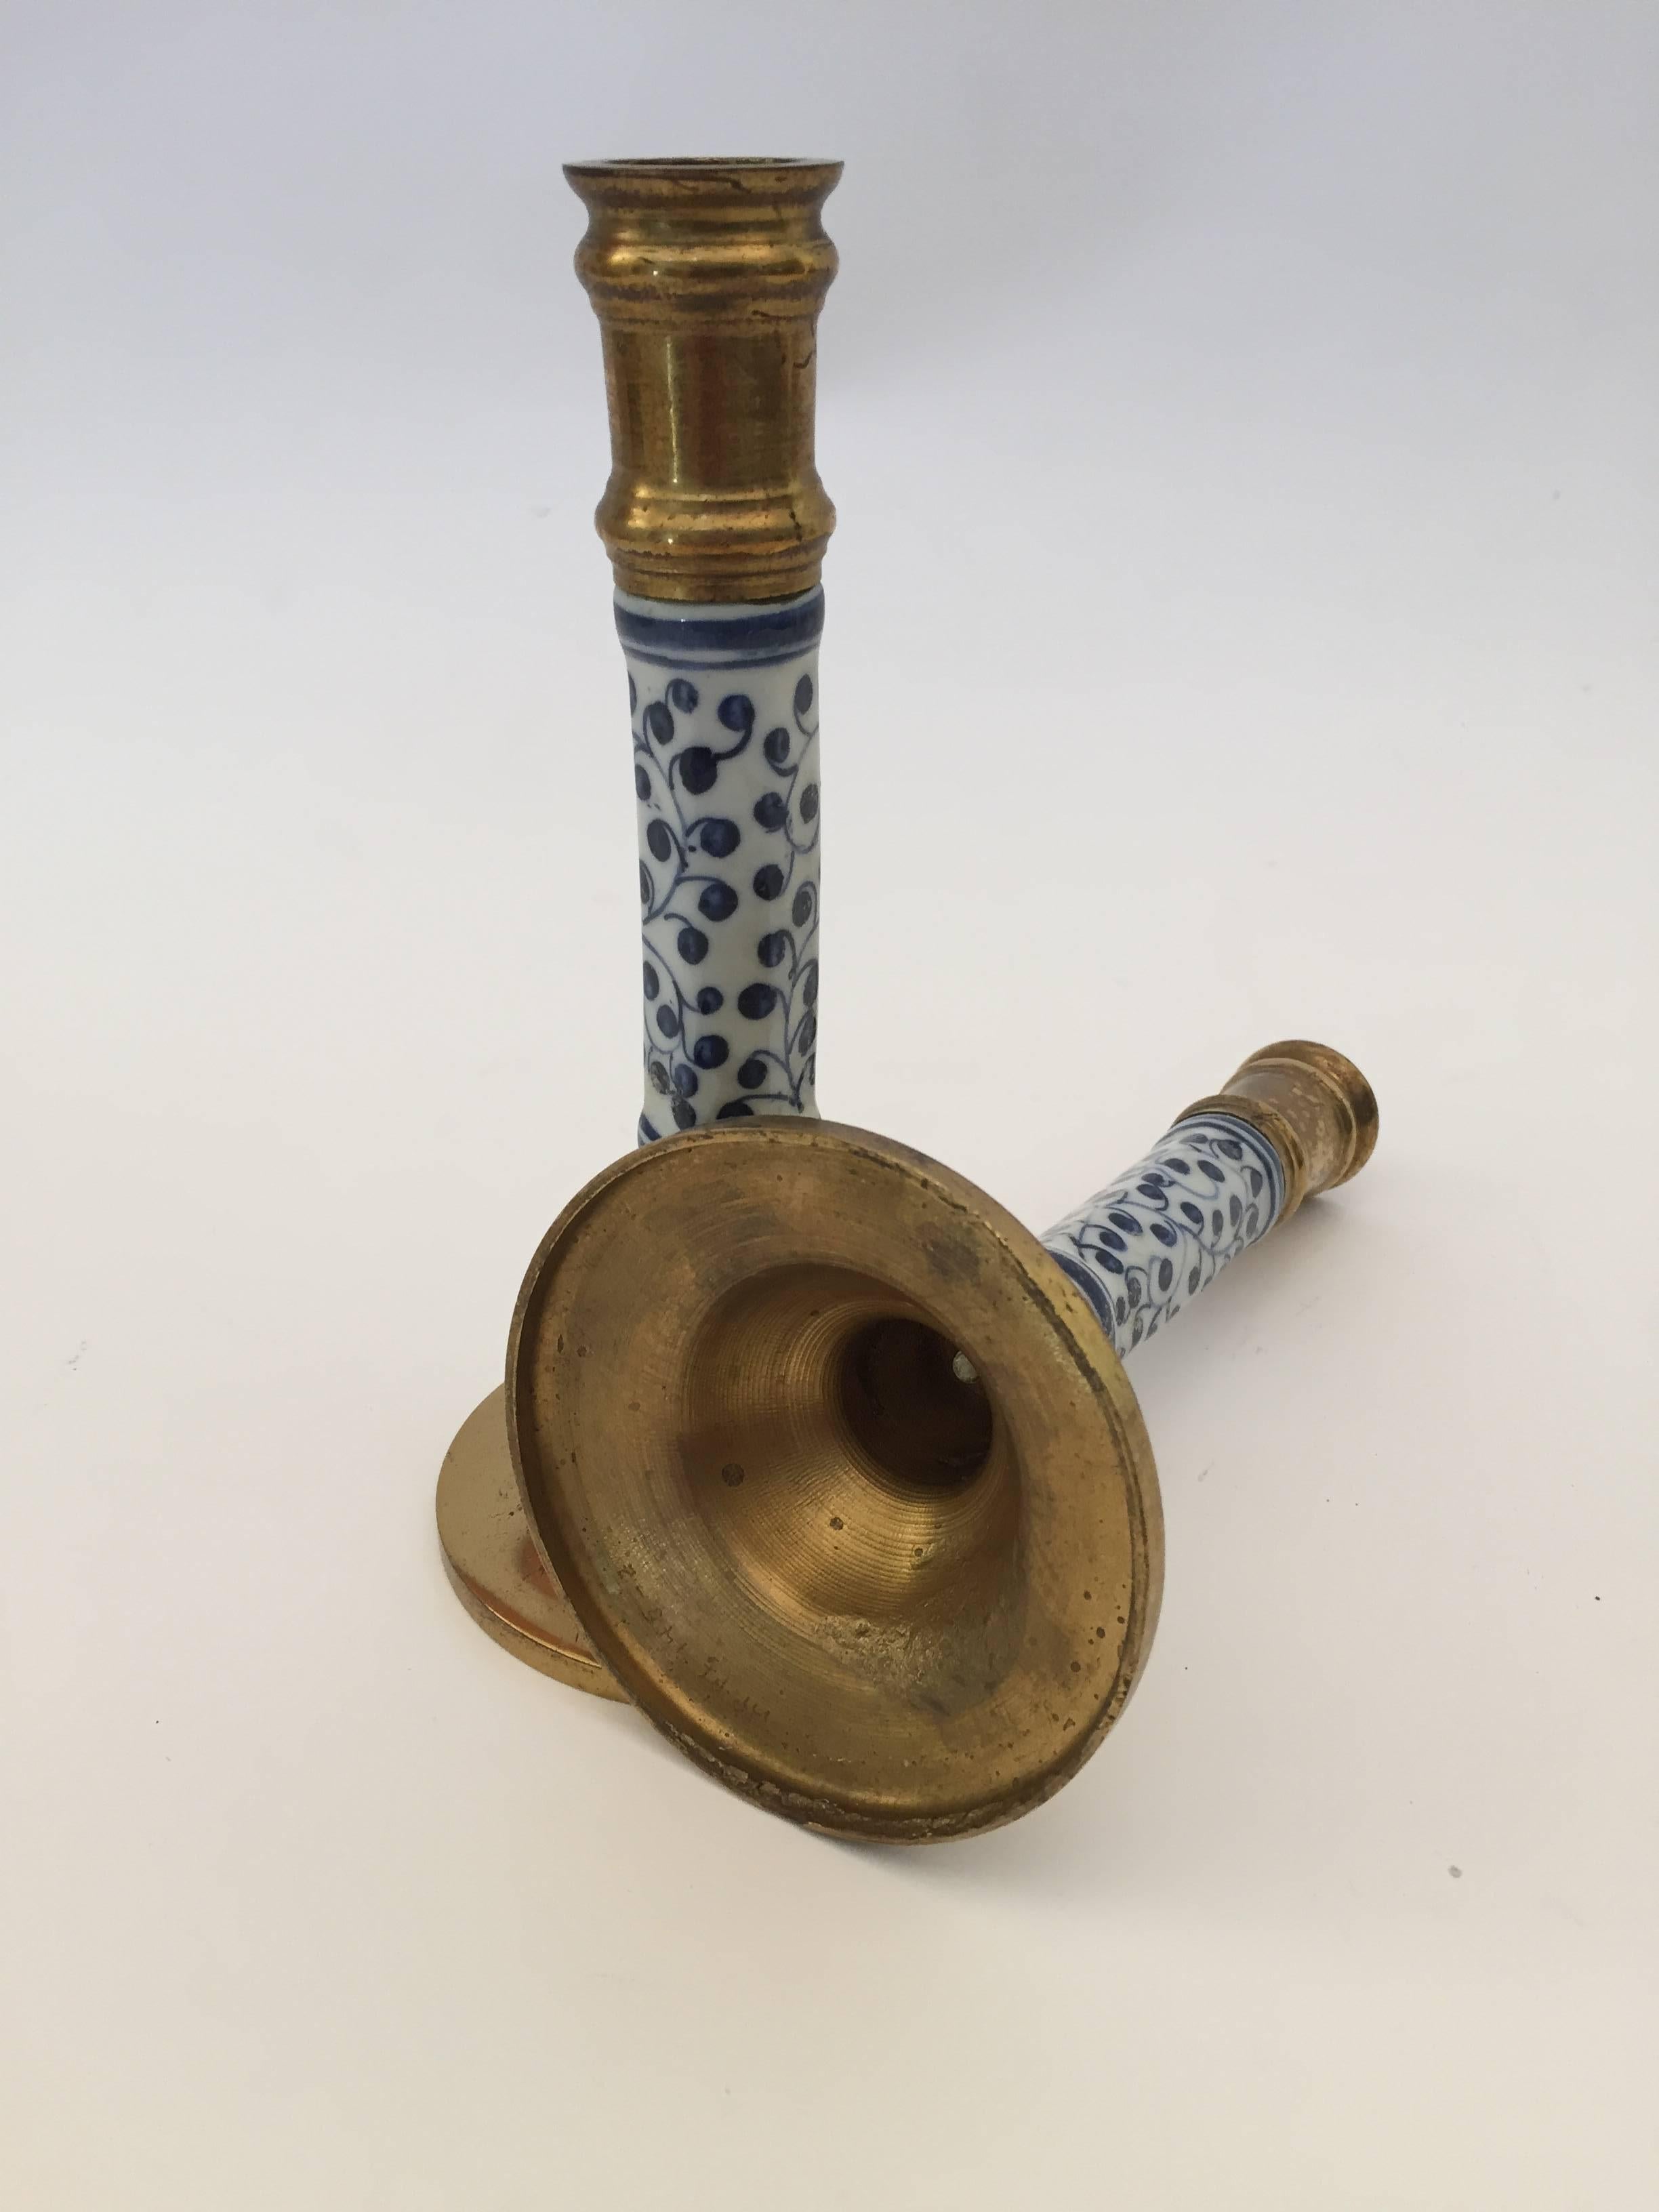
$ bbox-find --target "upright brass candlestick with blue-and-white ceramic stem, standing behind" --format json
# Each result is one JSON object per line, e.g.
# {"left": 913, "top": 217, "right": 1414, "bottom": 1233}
{"left": 438, "top": 161, "right": 840, "bottom": 1696}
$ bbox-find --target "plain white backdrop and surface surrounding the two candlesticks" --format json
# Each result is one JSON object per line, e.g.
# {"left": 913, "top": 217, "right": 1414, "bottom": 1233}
{"left": 0, "top": 0, "right": 1659, "bottom": 2212}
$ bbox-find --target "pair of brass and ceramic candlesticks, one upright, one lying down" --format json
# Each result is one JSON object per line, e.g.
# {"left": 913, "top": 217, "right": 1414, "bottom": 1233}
{"left": 438, "top": 159, "right": 1376, "bottom": 1843}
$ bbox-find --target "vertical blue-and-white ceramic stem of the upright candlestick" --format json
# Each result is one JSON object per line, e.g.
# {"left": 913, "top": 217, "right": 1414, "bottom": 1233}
{"left": 617, "top": 586, "right": 823, "bottom": 1143}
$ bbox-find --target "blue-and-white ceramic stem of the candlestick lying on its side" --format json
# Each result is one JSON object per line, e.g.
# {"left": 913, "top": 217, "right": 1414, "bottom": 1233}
{"left": 1042, "top": 1113, "right": 1285, "bottom": 1356}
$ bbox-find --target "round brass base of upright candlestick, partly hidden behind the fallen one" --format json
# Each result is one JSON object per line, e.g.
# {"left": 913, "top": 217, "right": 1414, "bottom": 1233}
{"left": 438, "top": 1387, "right": 626, "bottom": 1703}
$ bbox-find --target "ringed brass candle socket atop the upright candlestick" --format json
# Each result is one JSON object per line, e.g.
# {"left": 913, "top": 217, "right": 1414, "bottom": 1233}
{"left": 564, "top": 159, "right": 840, "bottom": 604}
